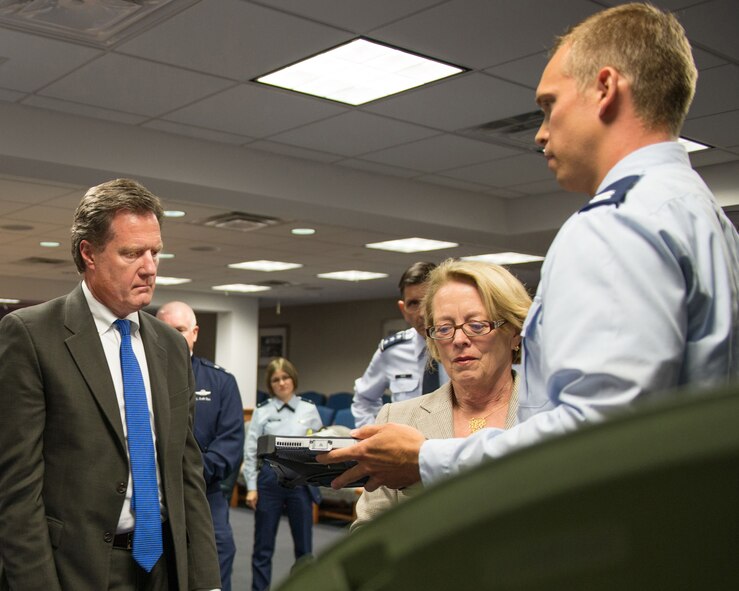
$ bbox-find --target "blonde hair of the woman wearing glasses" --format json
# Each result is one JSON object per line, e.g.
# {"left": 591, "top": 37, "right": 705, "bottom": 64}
{"left": 422, "top": 259, "right": 531, "bottom": 363}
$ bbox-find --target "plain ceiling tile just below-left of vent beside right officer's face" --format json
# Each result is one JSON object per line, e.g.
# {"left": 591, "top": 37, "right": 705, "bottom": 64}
{"left": 362, "top": 134, "right": 520, "bottom": 172}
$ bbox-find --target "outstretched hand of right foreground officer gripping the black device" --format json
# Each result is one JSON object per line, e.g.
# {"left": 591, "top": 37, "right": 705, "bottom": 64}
{"left": 316, "top": 423, "right": 426, "bottom": 492}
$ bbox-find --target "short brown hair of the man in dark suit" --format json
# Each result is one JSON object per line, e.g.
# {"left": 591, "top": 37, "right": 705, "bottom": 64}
{"left": 72, "top": 179, "right": 164, "bottom": 273}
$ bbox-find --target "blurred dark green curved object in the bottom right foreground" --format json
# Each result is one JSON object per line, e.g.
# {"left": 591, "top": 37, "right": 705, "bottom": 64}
{"left": 279, "top": 386, "right": 739, "bottom": 591}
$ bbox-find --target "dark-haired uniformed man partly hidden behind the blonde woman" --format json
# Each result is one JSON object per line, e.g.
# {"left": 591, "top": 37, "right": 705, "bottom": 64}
{"left": 352, "top": 262, "right": 449, "bottom": 427}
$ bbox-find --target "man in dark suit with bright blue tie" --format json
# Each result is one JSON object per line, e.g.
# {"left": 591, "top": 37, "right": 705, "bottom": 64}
{"left": 0, "top": 179, "right": 220, "bottom": 591}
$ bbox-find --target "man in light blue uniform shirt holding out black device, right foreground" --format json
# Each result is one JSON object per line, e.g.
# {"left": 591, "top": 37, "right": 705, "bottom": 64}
{"left": 324, "top": 3, "right": 739, "bottom": 490}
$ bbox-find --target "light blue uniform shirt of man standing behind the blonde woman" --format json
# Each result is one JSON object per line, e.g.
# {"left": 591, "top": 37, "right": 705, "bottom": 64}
{"left": 352, "top": 328, "right": 449, "bottom": 427}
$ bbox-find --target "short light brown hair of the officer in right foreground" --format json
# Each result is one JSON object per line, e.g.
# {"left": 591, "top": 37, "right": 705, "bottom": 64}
{"left": 552, "top": 3, "right": 698, "bottom": 137}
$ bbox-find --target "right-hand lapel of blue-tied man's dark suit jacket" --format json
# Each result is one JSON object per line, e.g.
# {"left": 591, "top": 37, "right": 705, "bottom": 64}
{"left": 139, "top": 312, "right": 170, "bottom": 463}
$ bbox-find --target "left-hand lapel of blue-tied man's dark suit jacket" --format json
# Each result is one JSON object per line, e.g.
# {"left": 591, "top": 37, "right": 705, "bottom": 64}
{"left": 64, "top": 286, "right": 126, "bottom": 453}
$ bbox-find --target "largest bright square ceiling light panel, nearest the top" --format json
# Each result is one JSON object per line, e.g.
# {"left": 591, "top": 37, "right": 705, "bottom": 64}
{"left": 256, "top": 39, "right": 464, "bottom": 106}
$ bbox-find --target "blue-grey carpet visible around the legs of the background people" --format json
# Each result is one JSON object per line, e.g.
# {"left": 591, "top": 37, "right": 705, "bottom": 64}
{"left": 230, "top": 507, "right": 349, "bottom": 591}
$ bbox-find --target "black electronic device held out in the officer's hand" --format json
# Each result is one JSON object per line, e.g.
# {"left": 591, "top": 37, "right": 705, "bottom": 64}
{"left": 257, "top": 435, "right": 367, "bottom": 488}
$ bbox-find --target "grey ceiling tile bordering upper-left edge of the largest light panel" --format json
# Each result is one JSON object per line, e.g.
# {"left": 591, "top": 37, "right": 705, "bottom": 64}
{"left": 118, "top": 0, "right": 353, "bottom": 81}
